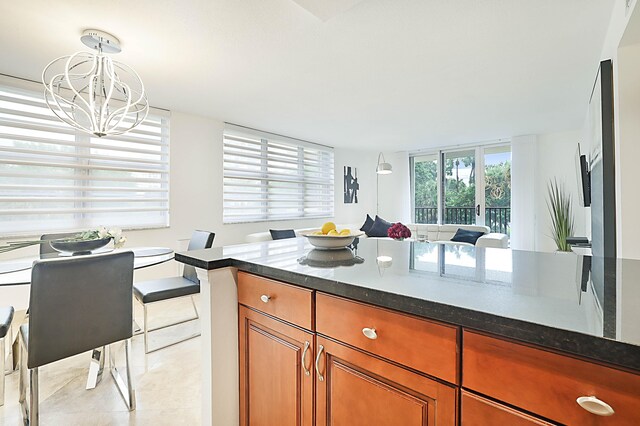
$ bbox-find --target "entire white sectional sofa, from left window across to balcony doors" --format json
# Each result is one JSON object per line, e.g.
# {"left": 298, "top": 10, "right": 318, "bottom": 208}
{"left": 245, "top": 223, "right": 509, "bottom": 248}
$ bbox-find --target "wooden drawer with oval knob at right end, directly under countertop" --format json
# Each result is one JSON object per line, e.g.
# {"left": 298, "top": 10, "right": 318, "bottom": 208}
{"left": 462, "top": 331, "right": 640, "bottom": 425}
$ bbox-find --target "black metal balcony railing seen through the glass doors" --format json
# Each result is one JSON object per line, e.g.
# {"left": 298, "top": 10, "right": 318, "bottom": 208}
{"left": 415, "top": 207, "right": 511, "bottom": 234}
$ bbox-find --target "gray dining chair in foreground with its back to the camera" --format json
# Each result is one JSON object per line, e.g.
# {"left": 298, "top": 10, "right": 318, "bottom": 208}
{"left": 19, "top": 251, "right": 135, "bottom": 426}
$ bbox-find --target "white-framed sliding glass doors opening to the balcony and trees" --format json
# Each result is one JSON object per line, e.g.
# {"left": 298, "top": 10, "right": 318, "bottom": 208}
{"left": 411, "top": 145, "right": 511, "bottom": 234}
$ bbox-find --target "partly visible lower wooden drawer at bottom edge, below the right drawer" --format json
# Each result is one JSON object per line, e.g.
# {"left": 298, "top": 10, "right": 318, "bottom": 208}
{"left": 461, "top": 391, "right": 552, "bottom": 426}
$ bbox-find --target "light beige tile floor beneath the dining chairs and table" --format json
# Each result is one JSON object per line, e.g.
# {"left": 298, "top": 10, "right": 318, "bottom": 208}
{"left": 0, "top": 298, "right": 201, "bottom": 426}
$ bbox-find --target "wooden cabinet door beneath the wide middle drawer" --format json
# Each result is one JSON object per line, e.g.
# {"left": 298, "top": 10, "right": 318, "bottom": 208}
{"left": 316, "top": 336, "right": 456, "bottom": 426}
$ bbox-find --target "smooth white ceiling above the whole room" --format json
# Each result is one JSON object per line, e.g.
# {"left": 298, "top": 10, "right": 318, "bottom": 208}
{"left": 0, "top": 0, "right": 613, "bottom": 151}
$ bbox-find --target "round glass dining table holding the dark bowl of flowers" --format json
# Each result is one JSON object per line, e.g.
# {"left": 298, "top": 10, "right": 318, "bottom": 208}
{"left": 0, "top": 247, "right": 173, "bottom": 389}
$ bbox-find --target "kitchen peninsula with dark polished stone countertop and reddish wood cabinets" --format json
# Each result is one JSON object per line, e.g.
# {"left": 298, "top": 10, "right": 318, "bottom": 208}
{"left": 175, "top": 238, "right": 640, "bottom": 425}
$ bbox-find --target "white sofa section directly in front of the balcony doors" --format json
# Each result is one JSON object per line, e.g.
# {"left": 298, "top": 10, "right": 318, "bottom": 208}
{"left": 407, "top": 223, "right": 509, "bottom": 248}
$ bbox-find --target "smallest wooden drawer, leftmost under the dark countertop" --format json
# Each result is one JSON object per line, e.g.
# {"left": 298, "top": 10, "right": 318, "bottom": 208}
{"left": 238, "top": 272, "right": 313, "bottom": 330}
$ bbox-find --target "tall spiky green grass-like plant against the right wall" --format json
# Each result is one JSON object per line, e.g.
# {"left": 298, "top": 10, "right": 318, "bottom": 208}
{"left": 547, "top": 179, "right": 573, "bottom": 251}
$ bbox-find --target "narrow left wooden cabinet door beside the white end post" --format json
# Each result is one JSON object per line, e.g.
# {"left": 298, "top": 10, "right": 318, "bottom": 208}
{"left": 239, "top": 306, "right": 314, "bottom": 426}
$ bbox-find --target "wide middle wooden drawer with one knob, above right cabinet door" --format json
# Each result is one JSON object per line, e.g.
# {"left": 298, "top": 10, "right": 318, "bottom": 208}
{"left": 316, "top": 293, "right": 458, "bottom": 383}
